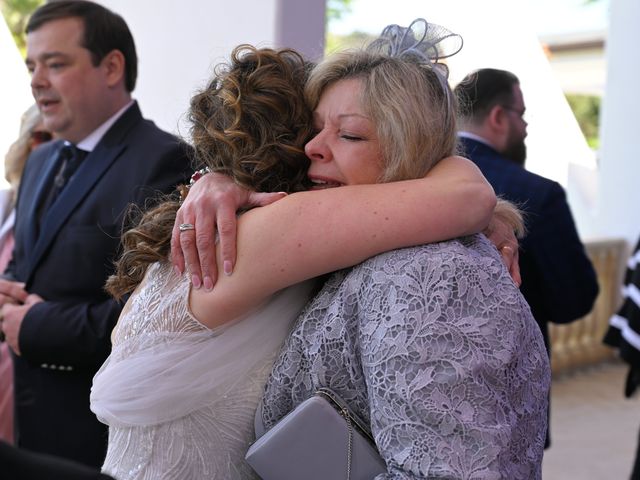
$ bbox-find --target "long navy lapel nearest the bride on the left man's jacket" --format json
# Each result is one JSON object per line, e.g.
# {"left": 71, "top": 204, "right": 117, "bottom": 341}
{"left": 27, "top": 104, "right": 142, "bottom": 281}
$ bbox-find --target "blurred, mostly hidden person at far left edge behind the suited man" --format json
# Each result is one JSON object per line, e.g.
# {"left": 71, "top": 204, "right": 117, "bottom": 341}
{"left": 0, "top": 105, "right": 52, "bottom": 443}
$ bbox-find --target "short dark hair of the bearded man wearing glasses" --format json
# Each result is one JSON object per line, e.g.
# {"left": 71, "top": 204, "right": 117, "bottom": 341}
{"left": 453, "top": 68, "right": 520, "bottom": 123}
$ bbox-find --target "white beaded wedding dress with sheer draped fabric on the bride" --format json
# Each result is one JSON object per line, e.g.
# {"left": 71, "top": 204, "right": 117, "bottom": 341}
{"left": 91, "top": 263, "right": 313, "bottom": 480}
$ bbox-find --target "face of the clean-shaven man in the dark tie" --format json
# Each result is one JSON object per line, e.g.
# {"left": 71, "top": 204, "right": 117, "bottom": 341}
{"left": 26, "top": 17, "right": 110, "bottom": 143}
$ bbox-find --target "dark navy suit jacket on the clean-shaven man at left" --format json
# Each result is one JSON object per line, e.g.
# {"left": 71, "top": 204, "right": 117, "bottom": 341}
{"left": 7, "top": 104, "right": 192, "bottom": 467}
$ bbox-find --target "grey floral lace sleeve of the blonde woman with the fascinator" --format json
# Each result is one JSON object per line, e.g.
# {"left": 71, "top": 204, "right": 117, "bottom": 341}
{"left": 358, "top": 236, "right": 549, "bottom": 480}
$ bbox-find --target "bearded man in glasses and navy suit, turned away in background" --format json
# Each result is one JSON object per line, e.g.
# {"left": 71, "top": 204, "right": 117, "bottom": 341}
{"left": 454, "top": 68, "right": 598, "bottom": 446}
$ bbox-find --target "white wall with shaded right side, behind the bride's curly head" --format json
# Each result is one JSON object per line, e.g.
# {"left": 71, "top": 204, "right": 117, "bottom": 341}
{"left": 100, "top": 0, "right": 324, "bottom": 136}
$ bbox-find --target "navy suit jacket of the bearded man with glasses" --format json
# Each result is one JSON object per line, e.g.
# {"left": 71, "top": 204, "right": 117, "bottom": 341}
{"left": 459, "top": 137, "right": 598, "bottom": 349}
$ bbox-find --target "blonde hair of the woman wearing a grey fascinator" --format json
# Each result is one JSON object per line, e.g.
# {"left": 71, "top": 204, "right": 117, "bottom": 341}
{"left": 305, "top": 50, "right": 456, "bottom": 182}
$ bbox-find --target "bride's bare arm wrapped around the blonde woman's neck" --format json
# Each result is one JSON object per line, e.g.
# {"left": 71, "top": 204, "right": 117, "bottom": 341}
{"left": 191, "top": 157, "right": 495, "bottom": 326}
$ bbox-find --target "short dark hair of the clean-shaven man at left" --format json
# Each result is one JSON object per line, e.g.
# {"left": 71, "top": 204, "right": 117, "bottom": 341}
{"left": 25, "top": 0, "right": 138, "bottom": 92}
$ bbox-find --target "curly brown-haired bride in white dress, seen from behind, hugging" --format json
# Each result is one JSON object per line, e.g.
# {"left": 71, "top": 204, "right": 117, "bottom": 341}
{"left": 91, "top": 26, "right": 528, "bottom": 479}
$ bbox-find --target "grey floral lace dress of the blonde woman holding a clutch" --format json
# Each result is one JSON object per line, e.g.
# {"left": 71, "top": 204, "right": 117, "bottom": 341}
{"left": 260, "top": 235, "right": 550, "bottom": 480}
